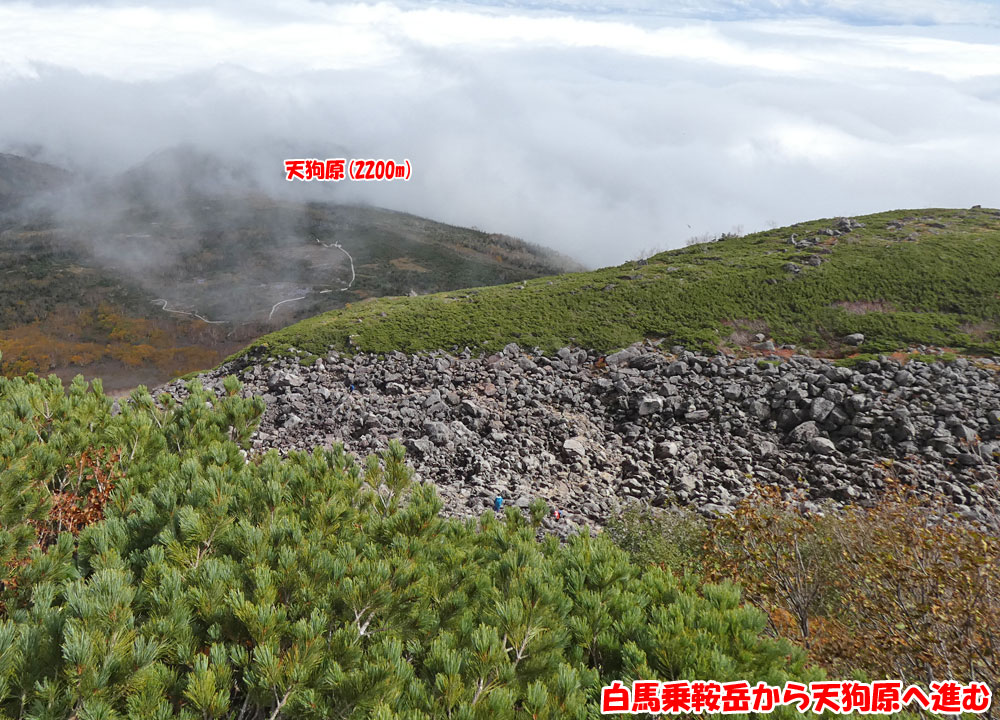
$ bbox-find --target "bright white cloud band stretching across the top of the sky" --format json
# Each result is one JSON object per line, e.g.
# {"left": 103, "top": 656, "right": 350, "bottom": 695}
{"left": 0, "top": 3, "right": 1000, "bottom": 80}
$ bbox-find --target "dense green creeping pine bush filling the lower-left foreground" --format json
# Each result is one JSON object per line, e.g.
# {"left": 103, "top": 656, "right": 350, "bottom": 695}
{"left": 0, "top": 366, "right": 812, "bottom": 720}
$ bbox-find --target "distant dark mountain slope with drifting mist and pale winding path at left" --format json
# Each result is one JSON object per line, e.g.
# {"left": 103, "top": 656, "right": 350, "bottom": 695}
{"left": 0, "top": 147, "right": 575, "bottom": 386}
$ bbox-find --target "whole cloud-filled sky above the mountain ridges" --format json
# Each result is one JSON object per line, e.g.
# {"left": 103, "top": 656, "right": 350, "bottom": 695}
{"left": 0, "top": 0, "right": 1000, "bottom": 265}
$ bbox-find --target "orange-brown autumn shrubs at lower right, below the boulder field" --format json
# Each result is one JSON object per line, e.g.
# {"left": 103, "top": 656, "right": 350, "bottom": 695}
{"left": 703, "top": 482, "right": 1000, "bottom": 685}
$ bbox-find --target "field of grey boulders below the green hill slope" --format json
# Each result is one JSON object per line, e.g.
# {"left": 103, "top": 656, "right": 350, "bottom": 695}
{"left": 158, "top": 343, "right": 1000, "bottom": 533}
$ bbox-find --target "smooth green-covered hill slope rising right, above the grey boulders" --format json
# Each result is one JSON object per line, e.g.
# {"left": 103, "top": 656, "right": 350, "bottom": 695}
{"left": 230, "top": 209, "right": 1000, "bottom": 366}
